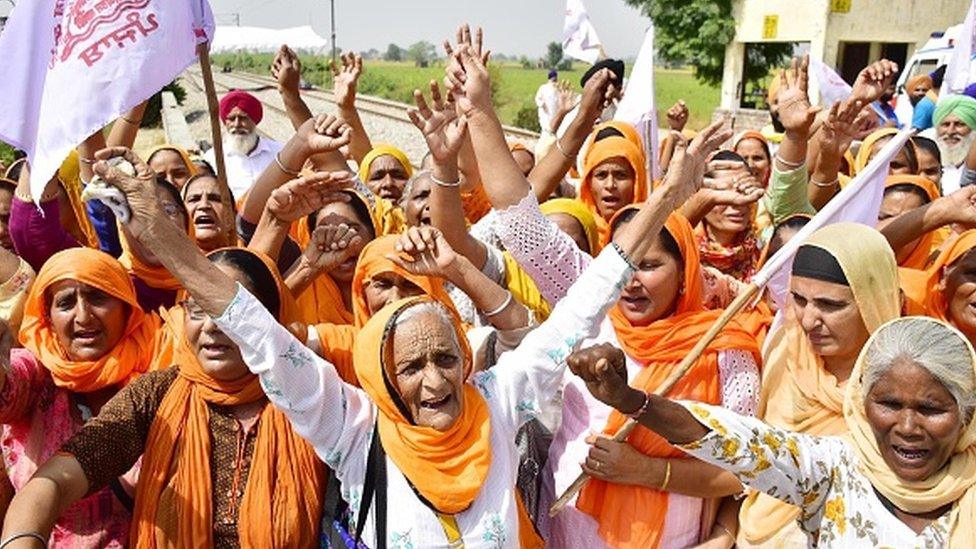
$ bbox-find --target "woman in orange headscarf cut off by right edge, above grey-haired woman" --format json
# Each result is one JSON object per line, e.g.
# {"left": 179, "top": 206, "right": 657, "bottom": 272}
{"left": 899, "top": 230, "right": 976, "bottom": 342}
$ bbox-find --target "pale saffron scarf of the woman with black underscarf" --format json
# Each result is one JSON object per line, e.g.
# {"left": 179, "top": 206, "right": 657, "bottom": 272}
{"left": 739, "top": 223, "right": 901, "bottom": 543}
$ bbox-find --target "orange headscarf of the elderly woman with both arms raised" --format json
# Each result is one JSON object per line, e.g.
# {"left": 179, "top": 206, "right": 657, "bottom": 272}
{"left": 354, "top": 297, "right": 492, "bottom": 515}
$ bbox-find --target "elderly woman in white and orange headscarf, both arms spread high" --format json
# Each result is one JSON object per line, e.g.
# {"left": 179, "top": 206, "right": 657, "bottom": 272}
{"left": 72, "top": 100, "right": 727, "bottom": 547}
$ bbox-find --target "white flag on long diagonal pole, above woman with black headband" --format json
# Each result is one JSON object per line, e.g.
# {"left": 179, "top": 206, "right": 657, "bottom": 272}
{"left": 752, "top": 129, "right": 912, "bottom": 308}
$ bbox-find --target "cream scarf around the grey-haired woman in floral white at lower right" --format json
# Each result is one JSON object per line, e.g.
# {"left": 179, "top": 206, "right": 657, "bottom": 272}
{"left": 844, "top": 317, "right": 976, "bottom": 547}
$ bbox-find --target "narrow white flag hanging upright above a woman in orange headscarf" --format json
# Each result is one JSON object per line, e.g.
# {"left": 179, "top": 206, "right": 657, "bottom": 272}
{"left": 614, "top": 21, "right": 661, "bottom": 179}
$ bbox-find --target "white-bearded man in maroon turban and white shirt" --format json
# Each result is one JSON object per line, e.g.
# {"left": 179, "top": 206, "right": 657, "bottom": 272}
{"left": 204, "top": 90, "right": 284, "bottom": 199}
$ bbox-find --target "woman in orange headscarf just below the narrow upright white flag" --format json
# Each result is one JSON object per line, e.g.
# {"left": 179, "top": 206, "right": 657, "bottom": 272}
{"left": 579, "top": 123, "right": 649, "bottom": 241}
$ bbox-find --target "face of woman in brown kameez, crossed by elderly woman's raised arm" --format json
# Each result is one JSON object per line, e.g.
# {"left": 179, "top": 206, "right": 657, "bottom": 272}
{"left": 183, "top": 263, "right": 255, "bottom": 381}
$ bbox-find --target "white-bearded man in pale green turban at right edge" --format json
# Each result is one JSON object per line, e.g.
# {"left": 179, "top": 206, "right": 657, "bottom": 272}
{"left": 932, "top": 95, "right": 976, "bottom": 195}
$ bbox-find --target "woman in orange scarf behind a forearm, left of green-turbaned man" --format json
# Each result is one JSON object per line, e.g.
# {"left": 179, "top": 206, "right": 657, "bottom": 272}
{"left": 878, "top": 175, "right": 948, "bottom": 269}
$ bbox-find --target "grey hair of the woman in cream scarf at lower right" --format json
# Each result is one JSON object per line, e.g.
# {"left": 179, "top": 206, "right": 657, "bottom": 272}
{"left": 862, "top": 317, "right": 976, "bottom": 421}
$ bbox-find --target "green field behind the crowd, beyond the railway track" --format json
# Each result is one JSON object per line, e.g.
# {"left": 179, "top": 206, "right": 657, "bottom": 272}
{"left": 213, "top": 54, "right": 719, "bottom": 129}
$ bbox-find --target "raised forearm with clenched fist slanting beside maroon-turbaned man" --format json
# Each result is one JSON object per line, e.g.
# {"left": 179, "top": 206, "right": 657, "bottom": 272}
{"left": 240, "top": 114, "right": 352, "bottom": 224}
